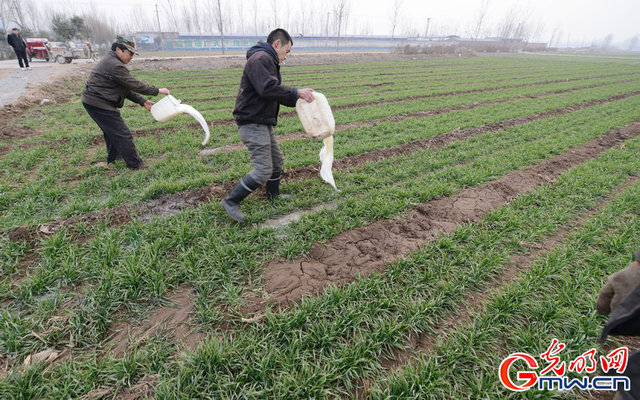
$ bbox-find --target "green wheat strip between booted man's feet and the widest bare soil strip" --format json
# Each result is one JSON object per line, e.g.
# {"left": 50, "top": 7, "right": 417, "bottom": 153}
{"left": 0, "top": 93, "right": 638, "bottom": 352}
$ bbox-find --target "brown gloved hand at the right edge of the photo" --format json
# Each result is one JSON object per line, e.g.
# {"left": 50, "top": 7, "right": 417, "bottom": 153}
{"left": 596, "top": 255, "right": 640, "bottom": 315}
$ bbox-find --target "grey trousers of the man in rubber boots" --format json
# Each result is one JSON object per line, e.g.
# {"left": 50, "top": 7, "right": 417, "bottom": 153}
{"left": 238, "top": 124, "right": 284, "bottom": 185}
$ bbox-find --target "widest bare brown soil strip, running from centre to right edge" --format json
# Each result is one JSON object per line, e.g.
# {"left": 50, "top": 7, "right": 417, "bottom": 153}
{"left": 258, "top": 122, "right": 640, "bottom": 309}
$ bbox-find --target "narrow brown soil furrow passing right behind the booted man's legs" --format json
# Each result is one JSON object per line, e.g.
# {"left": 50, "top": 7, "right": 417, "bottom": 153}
{"left": 7, "top": 91, "right": 640, "bottom": 242}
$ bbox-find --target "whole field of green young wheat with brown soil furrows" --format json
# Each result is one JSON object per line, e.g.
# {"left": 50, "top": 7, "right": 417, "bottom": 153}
{"left": 0, "top": 55, "right": 640, "bottom": 399}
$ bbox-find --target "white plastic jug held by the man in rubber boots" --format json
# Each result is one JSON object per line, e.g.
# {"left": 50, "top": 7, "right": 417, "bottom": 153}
{"left": 296, "top": 92, "right": 336, "bottom": 141}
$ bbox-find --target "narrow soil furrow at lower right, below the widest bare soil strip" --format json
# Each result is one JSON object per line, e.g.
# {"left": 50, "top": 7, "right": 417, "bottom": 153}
{"left": 382, "top": 176, "right": 640, "bottom": 376}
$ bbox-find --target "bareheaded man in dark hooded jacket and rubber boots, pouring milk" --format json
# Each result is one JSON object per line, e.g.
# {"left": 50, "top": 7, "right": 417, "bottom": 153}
{"left": 220, "top": 29, "right": 313, "bottom": 222}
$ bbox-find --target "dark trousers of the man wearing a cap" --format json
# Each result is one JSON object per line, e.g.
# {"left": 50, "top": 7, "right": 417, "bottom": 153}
{"left": 82, "top": 103, "right": 142, "bottom": 169}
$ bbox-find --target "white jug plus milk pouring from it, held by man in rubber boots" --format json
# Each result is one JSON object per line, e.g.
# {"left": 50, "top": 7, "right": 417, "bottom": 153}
{"left": 296, "top": 92, "right": 338, "bottom": 190}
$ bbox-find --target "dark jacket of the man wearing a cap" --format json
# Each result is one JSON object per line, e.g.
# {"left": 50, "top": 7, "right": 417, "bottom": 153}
{"left": 82, "top": 51, "right": 159, "bottom": 111}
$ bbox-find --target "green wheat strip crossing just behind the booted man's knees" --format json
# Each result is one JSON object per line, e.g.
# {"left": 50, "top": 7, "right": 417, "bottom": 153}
{"left": 1, "top": 78, "right": 638, "bottom": 228}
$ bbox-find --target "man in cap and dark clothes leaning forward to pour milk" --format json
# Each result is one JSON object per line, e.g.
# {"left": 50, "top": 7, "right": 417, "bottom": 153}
{"left": 81, "top": 35, "right": 170, "bottom": 169}
